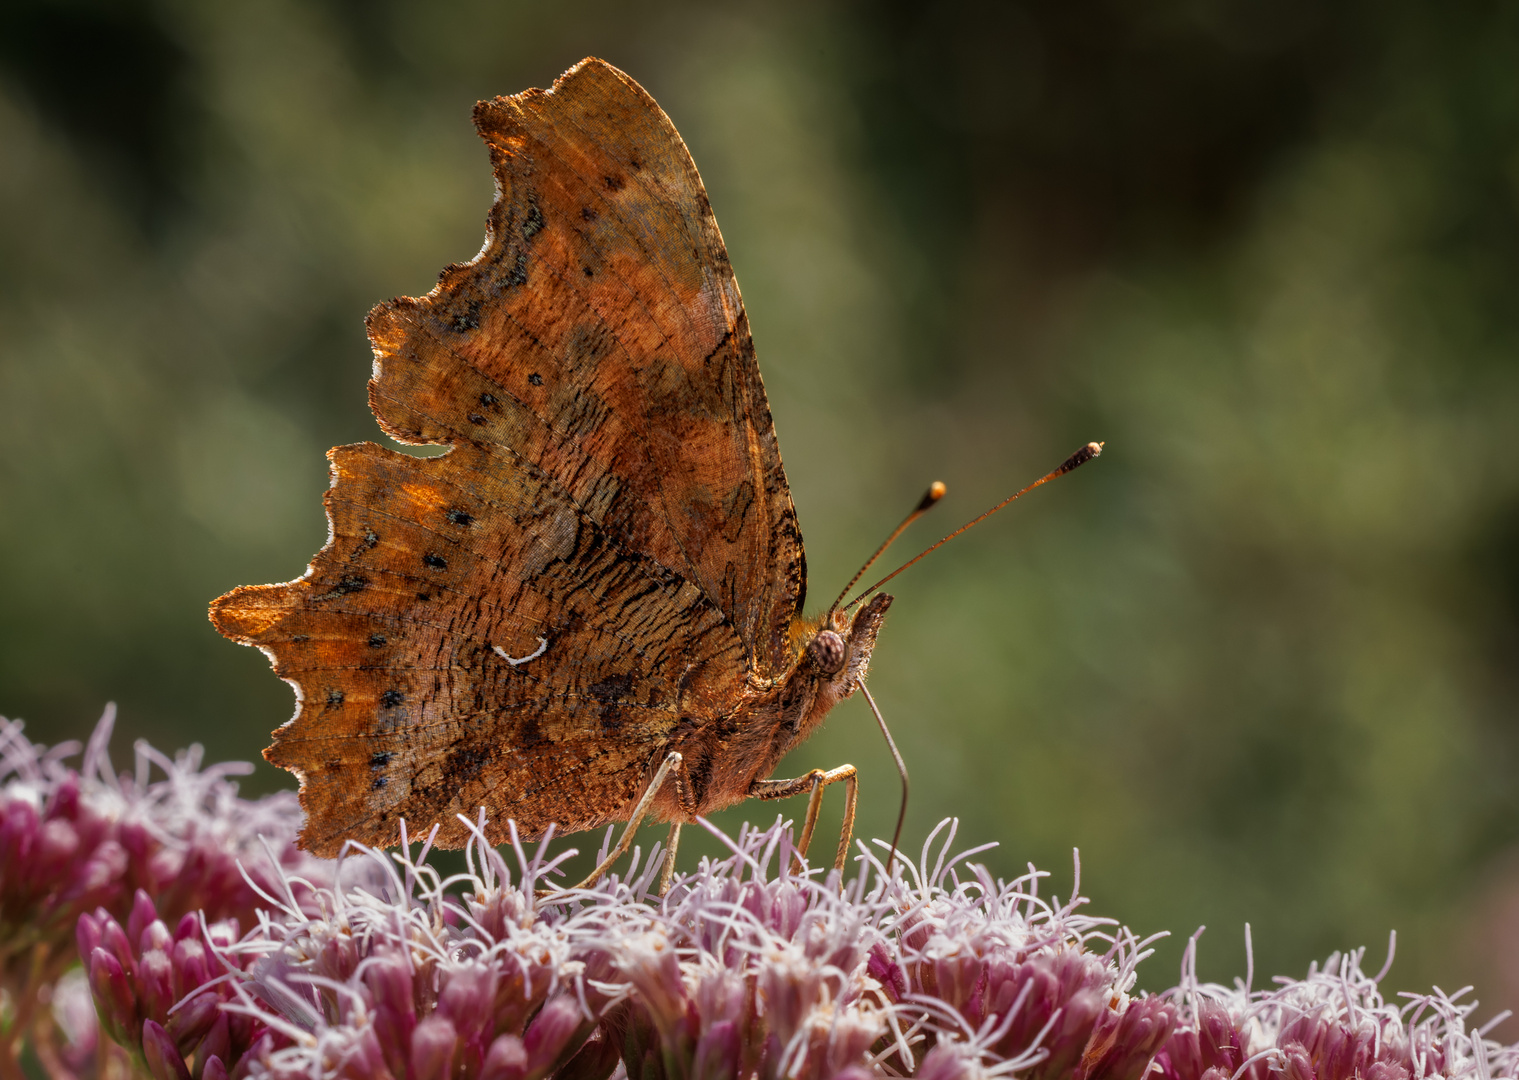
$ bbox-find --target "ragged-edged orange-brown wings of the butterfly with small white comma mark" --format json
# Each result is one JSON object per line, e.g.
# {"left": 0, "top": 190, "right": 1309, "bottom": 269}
{"left": 211, "top": 59, "right": 805, "bottom": 854}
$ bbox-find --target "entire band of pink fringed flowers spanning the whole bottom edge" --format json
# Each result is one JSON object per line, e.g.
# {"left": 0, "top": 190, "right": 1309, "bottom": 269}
{"left": 0, "top": 718, "right": 1519, "bottom": 1080}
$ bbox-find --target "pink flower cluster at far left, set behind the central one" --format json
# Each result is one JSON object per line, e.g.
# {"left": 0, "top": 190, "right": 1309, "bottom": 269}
{"left": 0, "top": 708, "right": 330, "bottom": 1071}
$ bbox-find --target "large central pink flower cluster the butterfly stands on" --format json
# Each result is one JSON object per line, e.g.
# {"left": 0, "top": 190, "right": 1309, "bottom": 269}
{"left": 81, "top": 822, "right": 1177, "bottom": 1080}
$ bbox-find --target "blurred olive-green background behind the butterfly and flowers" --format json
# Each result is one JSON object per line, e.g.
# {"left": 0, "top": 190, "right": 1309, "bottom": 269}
{"left": 0, "top": 0, "right": 1519, "bottom": 1014}
